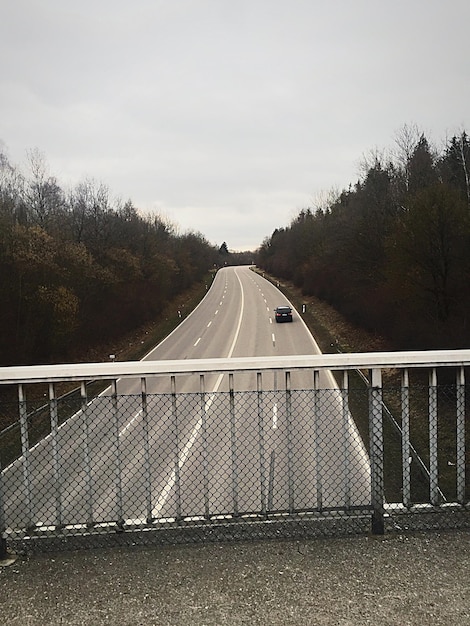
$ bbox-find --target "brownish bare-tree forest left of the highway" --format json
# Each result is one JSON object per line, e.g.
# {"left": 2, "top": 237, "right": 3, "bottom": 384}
{"left": 0, "top": 150, "right": 219, "bottom": 366}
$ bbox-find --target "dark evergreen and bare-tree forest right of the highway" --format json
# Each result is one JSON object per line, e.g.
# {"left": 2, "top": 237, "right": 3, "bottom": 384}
{"left": 257, "top": 126, "right": 470, "bottom": 349}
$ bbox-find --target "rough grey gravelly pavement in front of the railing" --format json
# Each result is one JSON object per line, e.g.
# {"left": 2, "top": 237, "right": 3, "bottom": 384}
{"left": 0, "top": 531, "right": 470, "bottom": 626}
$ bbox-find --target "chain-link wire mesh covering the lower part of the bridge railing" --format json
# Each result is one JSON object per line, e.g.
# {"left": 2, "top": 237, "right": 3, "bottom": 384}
{"left": 0, "top": 368, "right": 469, "bottom": 549}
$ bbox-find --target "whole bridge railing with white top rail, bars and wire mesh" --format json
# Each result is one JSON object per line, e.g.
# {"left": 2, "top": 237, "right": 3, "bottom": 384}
{"left": 0, "top": 350, "right": 470, "bottom": 552}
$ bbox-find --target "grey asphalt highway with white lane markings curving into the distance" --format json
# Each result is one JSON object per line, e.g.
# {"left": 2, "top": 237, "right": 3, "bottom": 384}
{"left": 3, "top": 266, "right": 370, "bottom": 528}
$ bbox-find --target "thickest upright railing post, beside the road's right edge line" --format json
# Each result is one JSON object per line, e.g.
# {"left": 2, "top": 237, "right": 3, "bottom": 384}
{"left": 369, "top": 369, "right": 385, "bottom": 535}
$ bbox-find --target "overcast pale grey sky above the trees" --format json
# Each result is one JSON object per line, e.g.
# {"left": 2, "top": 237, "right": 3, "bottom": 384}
{"left": 0, "top": 0, "right": 470, "bottom": 250}
